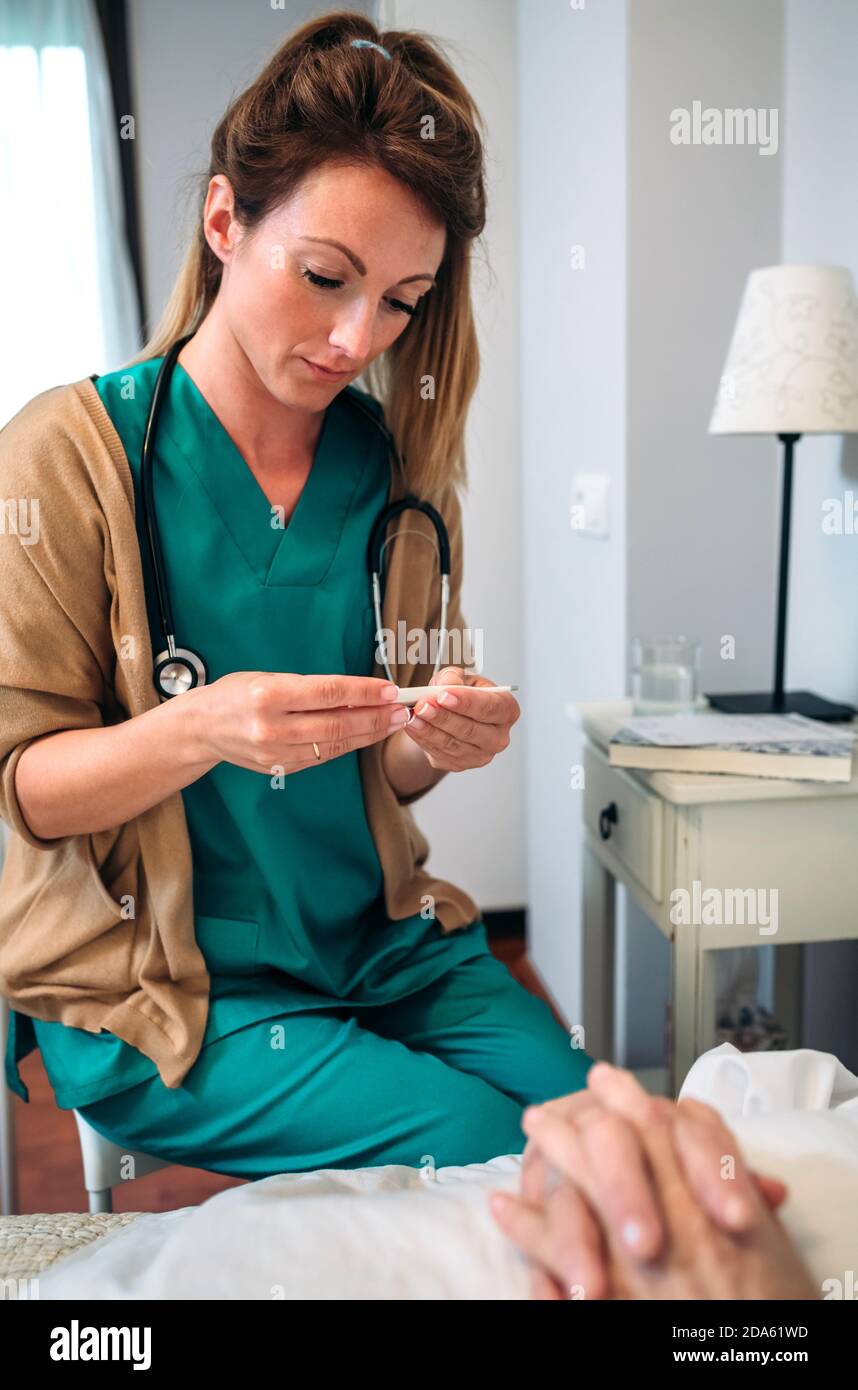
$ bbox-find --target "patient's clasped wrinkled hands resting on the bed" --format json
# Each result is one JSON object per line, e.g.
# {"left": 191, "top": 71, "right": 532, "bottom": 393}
{"left": 492, "top": 1063, "right": 819, "bottom": 1300}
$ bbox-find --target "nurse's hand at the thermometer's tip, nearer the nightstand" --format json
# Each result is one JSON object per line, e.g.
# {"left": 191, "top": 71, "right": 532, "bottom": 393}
{"left": 403, "top": 666, "right": 521, "bottom": 773}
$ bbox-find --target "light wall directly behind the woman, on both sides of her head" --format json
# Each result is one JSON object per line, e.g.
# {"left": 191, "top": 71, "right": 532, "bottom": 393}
{"left": 129, "top": 0, "right": 528, "bottom": 909}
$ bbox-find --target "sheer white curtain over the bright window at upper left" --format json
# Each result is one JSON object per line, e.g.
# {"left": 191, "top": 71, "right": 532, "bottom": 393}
{"left": 0, "top": 0, "right": 140, "bottom": 425}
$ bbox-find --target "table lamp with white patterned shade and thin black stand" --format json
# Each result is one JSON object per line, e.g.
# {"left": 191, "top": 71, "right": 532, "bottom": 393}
{"left": 706, "top": 265, "right": 858, "bottom": 721}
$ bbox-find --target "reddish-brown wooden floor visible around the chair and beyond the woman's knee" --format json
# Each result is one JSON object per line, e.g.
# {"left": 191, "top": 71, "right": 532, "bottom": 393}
{"left": 13, "top": 937, "right": 565, "bottom": 1212}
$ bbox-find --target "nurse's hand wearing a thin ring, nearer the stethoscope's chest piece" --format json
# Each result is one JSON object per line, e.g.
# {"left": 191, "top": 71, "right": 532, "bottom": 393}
{"left": 191, "top": 671, "right": 407, "bottom": 774}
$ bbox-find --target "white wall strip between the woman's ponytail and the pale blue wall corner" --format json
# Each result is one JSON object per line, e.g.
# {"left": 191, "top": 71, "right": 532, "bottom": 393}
{"left": 378, "top": 0, "right": 522, "bottom": 909}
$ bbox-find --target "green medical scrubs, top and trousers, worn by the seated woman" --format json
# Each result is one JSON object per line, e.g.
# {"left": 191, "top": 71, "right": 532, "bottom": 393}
{"left": 7, "top": 350, "right": 591, "bottom": 1177}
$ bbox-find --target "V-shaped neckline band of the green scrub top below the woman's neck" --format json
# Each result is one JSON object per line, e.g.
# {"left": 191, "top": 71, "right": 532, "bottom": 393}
{"left": 159, "top": 361, "right": 369, "bottom": 588}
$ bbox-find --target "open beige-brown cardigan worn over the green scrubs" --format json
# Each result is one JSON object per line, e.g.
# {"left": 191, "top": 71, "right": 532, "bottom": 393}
{"left": 0, "top": 378, "right": 480, "bottom": 1087}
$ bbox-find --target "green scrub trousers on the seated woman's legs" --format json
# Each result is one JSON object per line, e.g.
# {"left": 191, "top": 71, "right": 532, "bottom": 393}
{"left": 79, "top": 955, "right": 592, "bottom": 1180}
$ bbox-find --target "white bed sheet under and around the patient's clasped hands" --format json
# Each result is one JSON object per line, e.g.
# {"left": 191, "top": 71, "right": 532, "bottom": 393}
{"left": 39, "top": 1043, "right": 858, "bottom": 1301}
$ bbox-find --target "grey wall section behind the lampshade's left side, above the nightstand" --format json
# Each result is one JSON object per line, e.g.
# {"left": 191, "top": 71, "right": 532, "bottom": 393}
{"left": 624, "top": 0, "right": 784, "bottom": 1065}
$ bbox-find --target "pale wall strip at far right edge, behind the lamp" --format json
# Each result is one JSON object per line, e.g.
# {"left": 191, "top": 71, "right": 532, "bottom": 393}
{"left": 783, "top": 0, "right": 858, "bottom": 1068}
